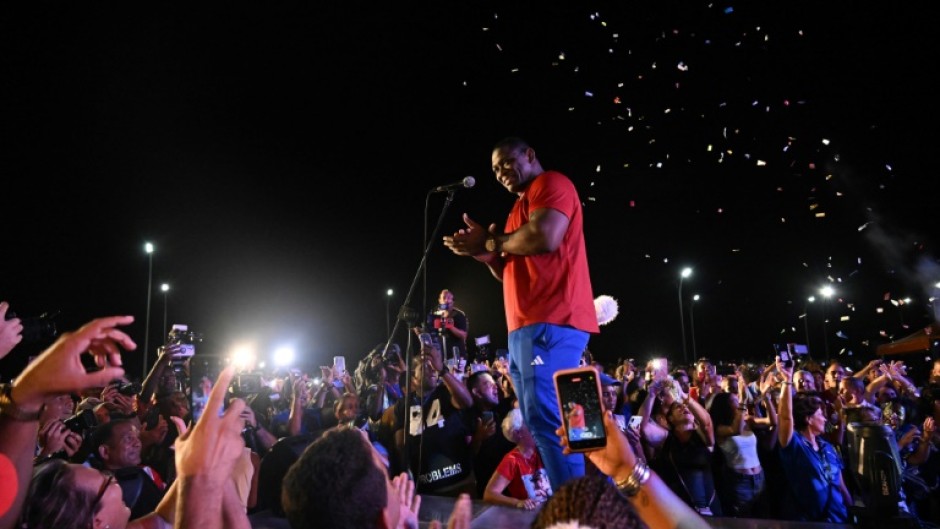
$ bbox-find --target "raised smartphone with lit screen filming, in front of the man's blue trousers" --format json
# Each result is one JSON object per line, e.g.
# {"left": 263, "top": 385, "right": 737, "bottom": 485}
{"left": 554, "top": 367, "right": 607, "bottom": 452}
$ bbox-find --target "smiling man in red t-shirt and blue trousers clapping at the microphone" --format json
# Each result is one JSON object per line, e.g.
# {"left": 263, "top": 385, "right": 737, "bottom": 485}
{"left": 444, "top": 137, "right": 599, "bottom": 489}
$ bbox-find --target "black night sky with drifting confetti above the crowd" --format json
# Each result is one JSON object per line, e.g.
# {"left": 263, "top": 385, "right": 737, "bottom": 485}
{"left": 0, "top": 1, "right": 940, "bottom": 379}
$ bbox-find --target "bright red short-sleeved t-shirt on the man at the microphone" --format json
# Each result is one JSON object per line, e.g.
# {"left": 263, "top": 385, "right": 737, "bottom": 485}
{"left": 503, "top": 171, "right": 600, "bottom": 333}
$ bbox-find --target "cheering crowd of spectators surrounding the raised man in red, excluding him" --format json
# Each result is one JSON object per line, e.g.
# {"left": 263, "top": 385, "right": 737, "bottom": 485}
{"left": 0, "top": 303, "right": 940, "bottom": 528}
